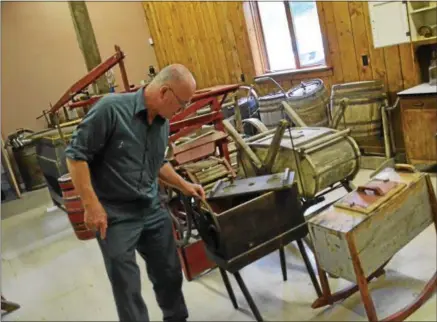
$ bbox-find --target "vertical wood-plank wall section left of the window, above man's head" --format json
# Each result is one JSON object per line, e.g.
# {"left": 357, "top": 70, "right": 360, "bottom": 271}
{"left": 144, "top": 1, "right": 254, "bottom": 88}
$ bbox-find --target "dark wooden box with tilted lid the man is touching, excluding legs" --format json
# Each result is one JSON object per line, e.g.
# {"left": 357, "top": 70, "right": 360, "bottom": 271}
{"left": 195, "top": 171, "right": 308, "bottom": 260}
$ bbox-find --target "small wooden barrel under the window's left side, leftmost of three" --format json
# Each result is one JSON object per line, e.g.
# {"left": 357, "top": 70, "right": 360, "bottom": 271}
{"left": 258, "top": 92, "right": 286, "bottom": 129}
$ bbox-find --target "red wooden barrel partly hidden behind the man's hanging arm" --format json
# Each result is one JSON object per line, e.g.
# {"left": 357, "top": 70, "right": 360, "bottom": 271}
{"left": 58, "top": 173, "right": 96, "bottom": 240}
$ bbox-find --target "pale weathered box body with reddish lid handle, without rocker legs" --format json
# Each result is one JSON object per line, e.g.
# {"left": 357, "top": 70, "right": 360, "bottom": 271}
{"left": 309, "top": 168, "right": 432, "bottom": 282}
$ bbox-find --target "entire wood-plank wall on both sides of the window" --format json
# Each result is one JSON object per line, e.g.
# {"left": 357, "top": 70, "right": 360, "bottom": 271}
{"left": 144, "top": 1, "right": 420, "bottom": 145}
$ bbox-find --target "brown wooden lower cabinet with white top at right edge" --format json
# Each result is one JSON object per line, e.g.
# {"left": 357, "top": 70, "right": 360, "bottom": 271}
{"left": 398, "top": 84, "right": 437, "bottom": 164}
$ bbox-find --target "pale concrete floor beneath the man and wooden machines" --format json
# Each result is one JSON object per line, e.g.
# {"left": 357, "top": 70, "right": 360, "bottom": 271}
{"left": 1, "top": 171, "right": 437, "bottom": 321}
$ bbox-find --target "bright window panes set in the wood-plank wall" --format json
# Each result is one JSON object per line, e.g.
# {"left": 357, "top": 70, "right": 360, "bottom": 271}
{"left": 253, "top": 1, "right": 326, "bottom": 72}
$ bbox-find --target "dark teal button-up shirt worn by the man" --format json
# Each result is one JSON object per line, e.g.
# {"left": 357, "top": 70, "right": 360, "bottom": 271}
{"left": 65, "top": 88, "right": 169, "bottom": 209}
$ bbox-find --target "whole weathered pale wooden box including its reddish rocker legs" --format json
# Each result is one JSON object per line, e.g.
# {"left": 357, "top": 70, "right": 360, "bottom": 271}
{"left": 309, "top": 165, "right": 437, "bottom": 321}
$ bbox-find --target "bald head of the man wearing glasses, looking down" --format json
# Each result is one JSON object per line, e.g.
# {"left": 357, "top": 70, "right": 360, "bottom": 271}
{"left": 145, "top": 64, "right": 196, "bottom": 118}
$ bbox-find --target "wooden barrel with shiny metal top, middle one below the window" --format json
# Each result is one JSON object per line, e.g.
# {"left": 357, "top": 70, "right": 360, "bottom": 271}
{"left": 287, "top": 79, "right": 329, "bottom": 127}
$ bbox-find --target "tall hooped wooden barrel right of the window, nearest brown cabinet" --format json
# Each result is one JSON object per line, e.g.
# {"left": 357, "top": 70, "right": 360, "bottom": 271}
{"left": 331, "top": 80, "right": 387, "bottom": 153}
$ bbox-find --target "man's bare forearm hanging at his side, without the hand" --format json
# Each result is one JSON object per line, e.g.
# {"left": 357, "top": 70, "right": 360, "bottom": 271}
{"left": 67, "top": 158, "right": 99, "bottom": 207}
